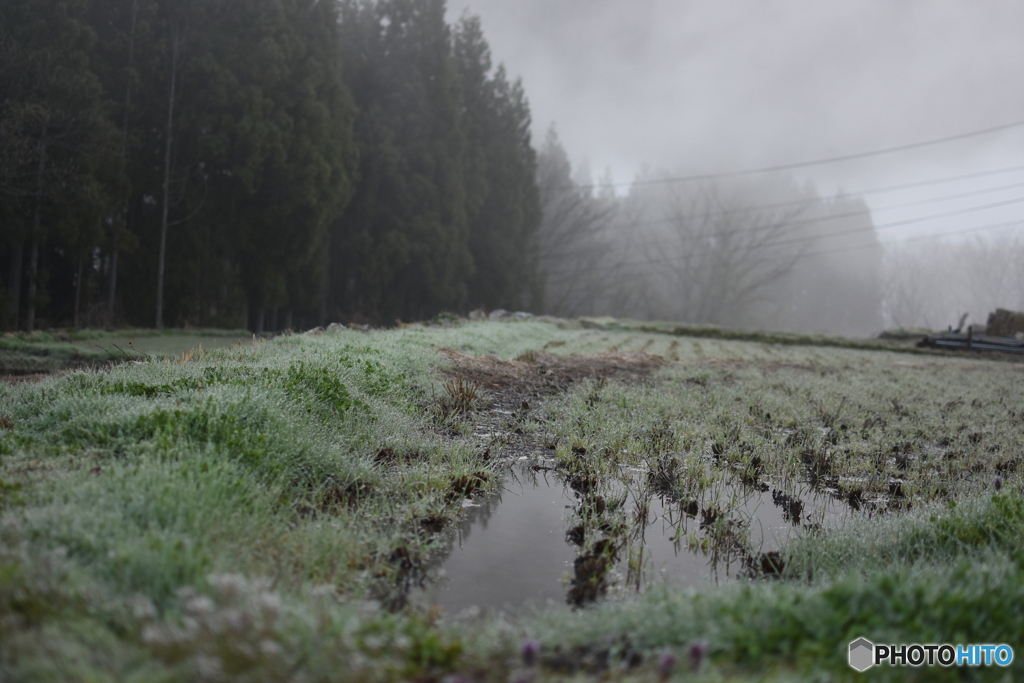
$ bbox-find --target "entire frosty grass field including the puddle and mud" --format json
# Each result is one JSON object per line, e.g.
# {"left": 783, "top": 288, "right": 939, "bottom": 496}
{"left": 0, "top": 318, "right": 1024, "bottom": 682}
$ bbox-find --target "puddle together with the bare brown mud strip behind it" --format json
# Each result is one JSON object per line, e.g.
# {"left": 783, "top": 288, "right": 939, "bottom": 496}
{"left": 409, "top": 351, "right": 850, "bottom": 614}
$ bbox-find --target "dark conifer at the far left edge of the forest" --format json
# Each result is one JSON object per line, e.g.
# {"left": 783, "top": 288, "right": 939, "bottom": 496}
{"left": 0, "top": 0, "right": 112, "bottom": 331}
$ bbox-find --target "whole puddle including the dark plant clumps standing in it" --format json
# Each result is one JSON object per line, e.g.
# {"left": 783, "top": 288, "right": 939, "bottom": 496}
{"left": 410, "top": 459, "right": 849, "bottom": 615}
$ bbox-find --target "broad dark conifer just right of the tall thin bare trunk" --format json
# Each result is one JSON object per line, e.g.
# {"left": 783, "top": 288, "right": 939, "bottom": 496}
{"left": 193, "top": 0, "right": 354, "bottom": 328}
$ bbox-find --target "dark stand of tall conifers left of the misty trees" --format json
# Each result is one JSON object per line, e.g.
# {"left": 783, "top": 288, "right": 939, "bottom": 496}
{"left": 0, "top": 0, "right": 543, "bottom": 330}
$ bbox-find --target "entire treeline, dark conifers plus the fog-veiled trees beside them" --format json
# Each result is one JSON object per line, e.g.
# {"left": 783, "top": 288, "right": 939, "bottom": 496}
{"left": 0, "top": 0, "right": 897, "bottom": 333}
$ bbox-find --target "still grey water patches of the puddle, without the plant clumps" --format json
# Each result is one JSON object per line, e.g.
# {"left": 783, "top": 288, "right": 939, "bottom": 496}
{"left": 411, "top": 464, "right": 846, "bottom": 614}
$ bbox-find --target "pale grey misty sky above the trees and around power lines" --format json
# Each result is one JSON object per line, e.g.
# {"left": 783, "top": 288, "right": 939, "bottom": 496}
{"left": 449, "top": 0, "right": 1024, "bottom": 242}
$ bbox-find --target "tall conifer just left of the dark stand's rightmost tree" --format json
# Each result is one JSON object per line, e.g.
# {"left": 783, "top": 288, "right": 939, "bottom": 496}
{"left": 332, "top": 0, "right": 472, "bottom": 321}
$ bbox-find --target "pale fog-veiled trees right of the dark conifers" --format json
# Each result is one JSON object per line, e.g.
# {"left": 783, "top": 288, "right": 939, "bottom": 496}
{"left": 538, "top": 129, "right": 883, "bottom": 335}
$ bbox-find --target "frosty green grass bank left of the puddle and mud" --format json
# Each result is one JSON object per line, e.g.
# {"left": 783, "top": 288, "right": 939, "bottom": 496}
{"left": 0, "top": 332, "right": 493, "bottom": 680}
